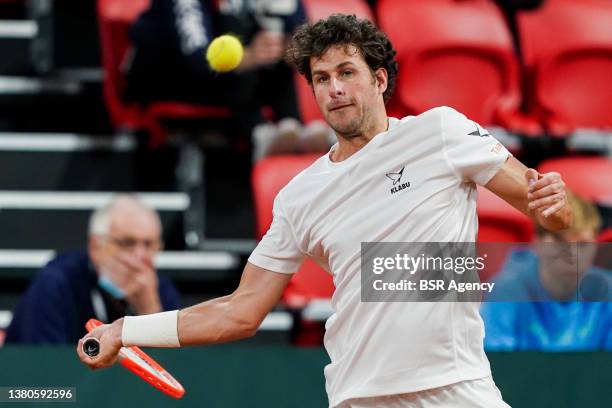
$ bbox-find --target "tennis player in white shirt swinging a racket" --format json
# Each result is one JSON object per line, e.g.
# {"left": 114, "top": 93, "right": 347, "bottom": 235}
{"left": 77, "top": 15, "right": 571, "bottom": 408}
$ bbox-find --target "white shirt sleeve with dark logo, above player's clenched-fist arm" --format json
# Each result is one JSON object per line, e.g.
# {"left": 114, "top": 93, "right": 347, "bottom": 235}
{"left": 440, "top": 107, "right": 511, "bottom": 185}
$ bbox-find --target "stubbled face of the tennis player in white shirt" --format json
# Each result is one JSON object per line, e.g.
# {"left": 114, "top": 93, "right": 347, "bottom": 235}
{"left": 310, "top": 45, "right": 386, "bottom": 137}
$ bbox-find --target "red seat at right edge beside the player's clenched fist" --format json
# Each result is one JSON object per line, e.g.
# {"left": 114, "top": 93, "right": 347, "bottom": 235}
{"left": 538, "top": 157, "right": 612, "bottom": 205}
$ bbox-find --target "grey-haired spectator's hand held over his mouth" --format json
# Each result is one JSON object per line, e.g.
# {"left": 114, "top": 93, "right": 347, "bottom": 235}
{"left": 101, "top": 253, "right": 162, "bottom": 315}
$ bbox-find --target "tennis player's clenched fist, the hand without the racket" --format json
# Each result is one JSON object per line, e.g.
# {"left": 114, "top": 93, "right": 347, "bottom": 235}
{"left": 525, "top": 169, "right": 567, "bottom": 218}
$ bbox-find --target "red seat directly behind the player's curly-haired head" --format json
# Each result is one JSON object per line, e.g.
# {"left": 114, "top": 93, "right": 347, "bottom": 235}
{"left": 295, "top": 0, "right": 374, "bottom": 123}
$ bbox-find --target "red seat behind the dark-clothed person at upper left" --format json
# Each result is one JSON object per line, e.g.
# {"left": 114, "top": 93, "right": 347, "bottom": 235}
{"left": 98, "top": 0, "right": 230, "bottom": 145}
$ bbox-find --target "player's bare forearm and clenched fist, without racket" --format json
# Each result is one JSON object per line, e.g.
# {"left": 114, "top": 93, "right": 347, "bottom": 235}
{"left": 485, "top": 157, "right": 572, "bottom": 231}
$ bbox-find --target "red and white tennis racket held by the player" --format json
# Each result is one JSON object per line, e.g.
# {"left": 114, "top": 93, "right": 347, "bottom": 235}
{"left": 83, "top": 319, "right": 185, "bottom": 399}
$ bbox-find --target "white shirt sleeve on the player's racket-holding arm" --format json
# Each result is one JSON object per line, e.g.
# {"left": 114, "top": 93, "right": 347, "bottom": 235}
{"left": 249, "top": 195, "right": 305, "bottom": 273}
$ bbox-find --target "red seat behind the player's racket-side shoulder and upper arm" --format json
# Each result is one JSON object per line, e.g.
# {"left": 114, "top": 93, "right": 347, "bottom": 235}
{"left": 252, "top": 154, "right": 335, "bottom": 308}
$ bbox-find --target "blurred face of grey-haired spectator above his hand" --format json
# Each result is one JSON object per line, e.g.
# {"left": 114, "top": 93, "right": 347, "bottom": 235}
{"left": 90, "top": 208, "right": 162, "bottom": 267}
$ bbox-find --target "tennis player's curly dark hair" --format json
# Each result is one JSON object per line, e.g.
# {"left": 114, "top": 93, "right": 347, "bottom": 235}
{"left": 285, "top": 14, "right": 397, "bottom": 103}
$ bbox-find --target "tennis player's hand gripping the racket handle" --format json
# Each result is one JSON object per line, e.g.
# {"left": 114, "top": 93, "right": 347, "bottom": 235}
{"left": 77, "top": 319, "right": 123, "bottom": 370}
